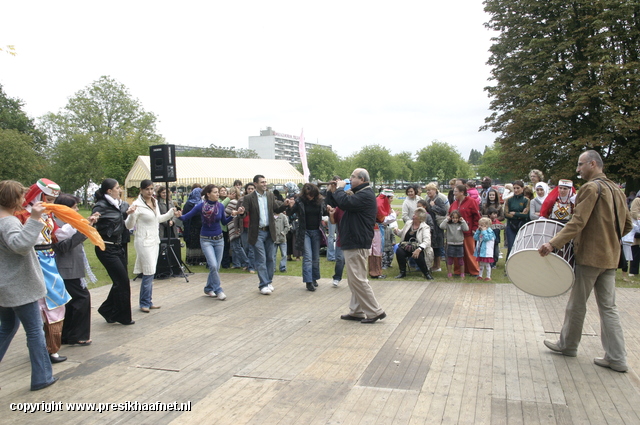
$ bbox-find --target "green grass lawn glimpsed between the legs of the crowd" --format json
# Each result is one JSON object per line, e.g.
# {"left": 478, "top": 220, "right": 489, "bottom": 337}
{"left": 80, "top": 203, "right": 640, "bottom": 288}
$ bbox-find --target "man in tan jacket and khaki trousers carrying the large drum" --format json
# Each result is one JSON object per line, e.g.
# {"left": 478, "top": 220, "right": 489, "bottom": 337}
{"left": 538, "top": 150, "right": 632, "bottom": 372}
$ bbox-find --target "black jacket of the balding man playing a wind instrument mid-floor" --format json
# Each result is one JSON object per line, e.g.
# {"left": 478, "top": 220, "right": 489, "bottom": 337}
{"left": 327, "top": 182, "right": 378, "bottom": 249}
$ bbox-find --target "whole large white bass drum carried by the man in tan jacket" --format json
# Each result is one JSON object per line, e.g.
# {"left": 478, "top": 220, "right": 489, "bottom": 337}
{"left": 505, "top": 219, "right": 575, "bottom": 297}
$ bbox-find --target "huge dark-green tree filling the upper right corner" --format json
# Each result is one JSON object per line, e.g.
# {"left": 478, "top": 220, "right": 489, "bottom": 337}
{"left": 483, "top": 0, "right": 640, "bottom": 187}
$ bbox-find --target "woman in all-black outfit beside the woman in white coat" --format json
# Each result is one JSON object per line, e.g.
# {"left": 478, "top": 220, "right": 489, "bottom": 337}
{"left": 93, "top": 179, "right": 135, "bottom": 325}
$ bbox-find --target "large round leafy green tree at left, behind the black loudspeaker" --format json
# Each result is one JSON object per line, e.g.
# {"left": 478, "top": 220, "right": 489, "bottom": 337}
{"left": 40, "top": 76, "right": 163, "bottom": 196}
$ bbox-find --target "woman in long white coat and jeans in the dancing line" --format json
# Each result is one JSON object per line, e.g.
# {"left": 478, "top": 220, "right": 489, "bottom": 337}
{"left": 125, "top": 180, "right": 180, "bottom": 313}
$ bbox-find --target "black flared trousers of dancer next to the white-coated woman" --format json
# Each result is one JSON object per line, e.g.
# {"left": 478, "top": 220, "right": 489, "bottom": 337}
{"left": 96, "top": 244, "right": 131, "bottom": 322}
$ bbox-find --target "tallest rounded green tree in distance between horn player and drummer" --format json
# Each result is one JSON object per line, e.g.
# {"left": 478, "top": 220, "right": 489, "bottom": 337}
{"left": 414, "top": 140, "right": 473, "bottom": 182}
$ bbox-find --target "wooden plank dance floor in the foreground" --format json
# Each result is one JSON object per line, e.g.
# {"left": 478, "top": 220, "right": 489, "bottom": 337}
{"left": 0, "top": 270, "right": 640, "bottom": 425}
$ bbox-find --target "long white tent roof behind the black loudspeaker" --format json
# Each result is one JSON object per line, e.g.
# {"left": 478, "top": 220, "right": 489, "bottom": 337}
{"left": 124, "top": 156, "right": 305, "bottom": 195}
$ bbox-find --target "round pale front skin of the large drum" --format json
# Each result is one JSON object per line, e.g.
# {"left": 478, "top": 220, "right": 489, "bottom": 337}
{"left": 505, "top": 249, "right": 574, "bottom": 297}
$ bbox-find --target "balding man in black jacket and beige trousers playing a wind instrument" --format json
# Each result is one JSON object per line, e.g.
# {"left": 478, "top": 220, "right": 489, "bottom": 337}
{"left": 327, "top": 168, "right": 387, "bottom": 323}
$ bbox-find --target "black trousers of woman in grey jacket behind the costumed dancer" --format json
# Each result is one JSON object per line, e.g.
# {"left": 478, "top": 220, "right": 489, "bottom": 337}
{"left": 62, "top": 279, "right": 91, "bottom": 344}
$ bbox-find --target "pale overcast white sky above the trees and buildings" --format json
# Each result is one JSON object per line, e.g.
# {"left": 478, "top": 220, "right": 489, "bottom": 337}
{"left": 0, "top": 0, "right": 495, "bottom": 159}
